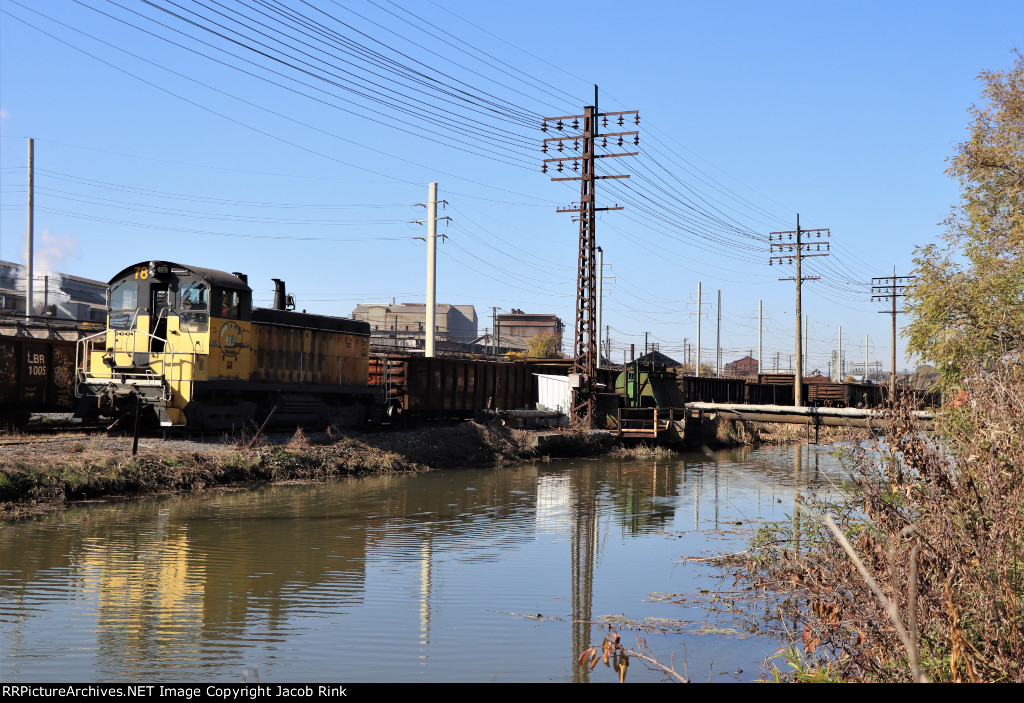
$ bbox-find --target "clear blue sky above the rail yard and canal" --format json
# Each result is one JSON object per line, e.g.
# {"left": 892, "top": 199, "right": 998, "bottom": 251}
{"left": 0, "top": 0, "right": 1024, "bottom": 370}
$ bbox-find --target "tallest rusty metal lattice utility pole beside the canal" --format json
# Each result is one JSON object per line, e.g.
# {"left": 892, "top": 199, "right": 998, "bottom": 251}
{"left": 541, "top": 86, "right": 640, "bottom": 430}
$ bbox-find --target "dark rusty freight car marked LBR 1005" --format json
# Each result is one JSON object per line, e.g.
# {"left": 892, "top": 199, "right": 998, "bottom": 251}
{"left": 0, "top": 319, "right": 80, "bottom": 426}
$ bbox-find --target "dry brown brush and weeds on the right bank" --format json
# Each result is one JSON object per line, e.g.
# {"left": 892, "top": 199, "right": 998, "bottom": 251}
{"left": 752, "top": 367, "right": 1024, "bottom": 682}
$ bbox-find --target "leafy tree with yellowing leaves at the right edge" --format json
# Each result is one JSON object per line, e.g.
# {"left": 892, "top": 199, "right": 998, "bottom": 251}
{"left": 906, "top": 50, "right": 1024, "bottom": 387}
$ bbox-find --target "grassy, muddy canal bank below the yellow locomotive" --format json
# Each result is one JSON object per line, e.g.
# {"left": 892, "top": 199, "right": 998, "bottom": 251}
{"left": 0, "top": 423, "right": 613, "bottom": 520}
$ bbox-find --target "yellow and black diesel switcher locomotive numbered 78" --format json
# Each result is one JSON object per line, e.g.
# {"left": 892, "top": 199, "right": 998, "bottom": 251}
{"left": 76, "top": 261, "right": 379, "bottom": 430}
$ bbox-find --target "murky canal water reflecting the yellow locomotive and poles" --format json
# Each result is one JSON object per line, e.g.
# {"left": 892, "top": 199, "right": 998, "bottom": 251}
{"left": 0, "top": 446, "right": 842, "bottom": 683}
